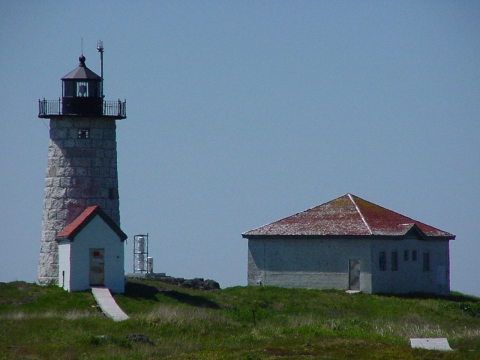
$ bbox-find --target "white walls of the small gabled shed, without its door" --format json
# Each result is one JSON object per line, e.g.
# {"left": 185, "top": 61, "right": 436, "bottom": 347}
{"left": 59, "top": 215, "right": 125, "bottom": 293}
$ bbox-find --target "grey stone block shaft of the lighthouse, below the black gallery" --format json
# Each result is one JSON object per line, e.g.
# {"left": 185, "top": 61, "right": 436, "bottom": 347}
{"left": 37, "top": 116, "right": 120, "bottom": 285}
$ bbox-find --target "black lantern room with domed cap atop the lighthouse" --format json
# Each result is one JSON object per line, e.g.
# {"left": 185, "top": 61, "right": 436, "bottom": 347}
{"left": 62, "top": 55, "right": 103, "bottom": 116}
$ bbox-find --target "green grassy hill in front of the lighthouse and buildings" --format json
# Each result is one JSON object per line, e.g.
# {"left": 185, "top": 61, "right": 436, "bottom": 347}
{"left": 0, "top": 280, "right": 480, "bottom": 359}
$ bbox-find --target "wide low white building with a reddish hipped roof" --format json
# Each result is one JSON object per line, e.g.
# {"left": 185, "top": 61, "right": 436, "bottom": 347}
{"left": 242, "top": 194, "right": 455, "bottom": 295}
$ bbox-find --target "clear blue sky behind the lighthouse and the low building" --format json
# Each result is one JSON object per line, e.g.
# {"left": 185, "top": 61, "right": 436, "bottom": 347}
{"left": 0, "top": 0, "right": 480, "bottom": 296}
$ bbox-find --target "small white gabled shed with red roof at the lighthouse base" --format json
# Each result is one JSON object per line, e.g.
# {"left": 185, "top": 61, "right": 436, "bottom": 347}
{"left": 56, "top": 206, "right": 127, "bottom": 293}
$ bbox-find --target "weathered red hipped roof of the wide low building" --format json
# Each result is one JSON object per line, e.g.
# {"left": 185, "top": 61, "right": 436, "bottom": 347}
{"left": 242, "top": 194, "right": 455, "bottom": 240}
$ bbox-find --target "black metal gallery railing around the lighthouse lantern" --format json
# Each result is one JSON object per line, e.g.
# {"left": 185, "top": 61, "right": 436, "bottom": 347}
{"left": 38, "top": 99, "right": 127, "bottom": 119}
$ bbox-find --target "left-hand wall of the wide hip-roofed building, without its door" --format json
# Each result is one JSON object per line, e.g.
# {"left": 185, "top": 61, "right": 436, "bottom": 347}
{"left": 248, "top": 239, "right": 371, "bottom": 293}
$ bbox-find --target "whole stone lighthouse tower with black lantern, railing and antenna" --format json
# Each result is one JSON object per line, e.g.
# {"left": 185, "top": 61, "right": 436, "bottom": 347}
{"left": 37, "top": 41, "right": 126, "bottom": 284}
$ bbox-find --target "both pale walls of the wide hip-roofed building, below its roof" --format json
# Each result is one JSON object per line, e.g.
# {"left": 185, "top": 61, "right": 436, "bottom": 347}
{"left": 248, "top": 238, "right": 450, "bottom": 295}
